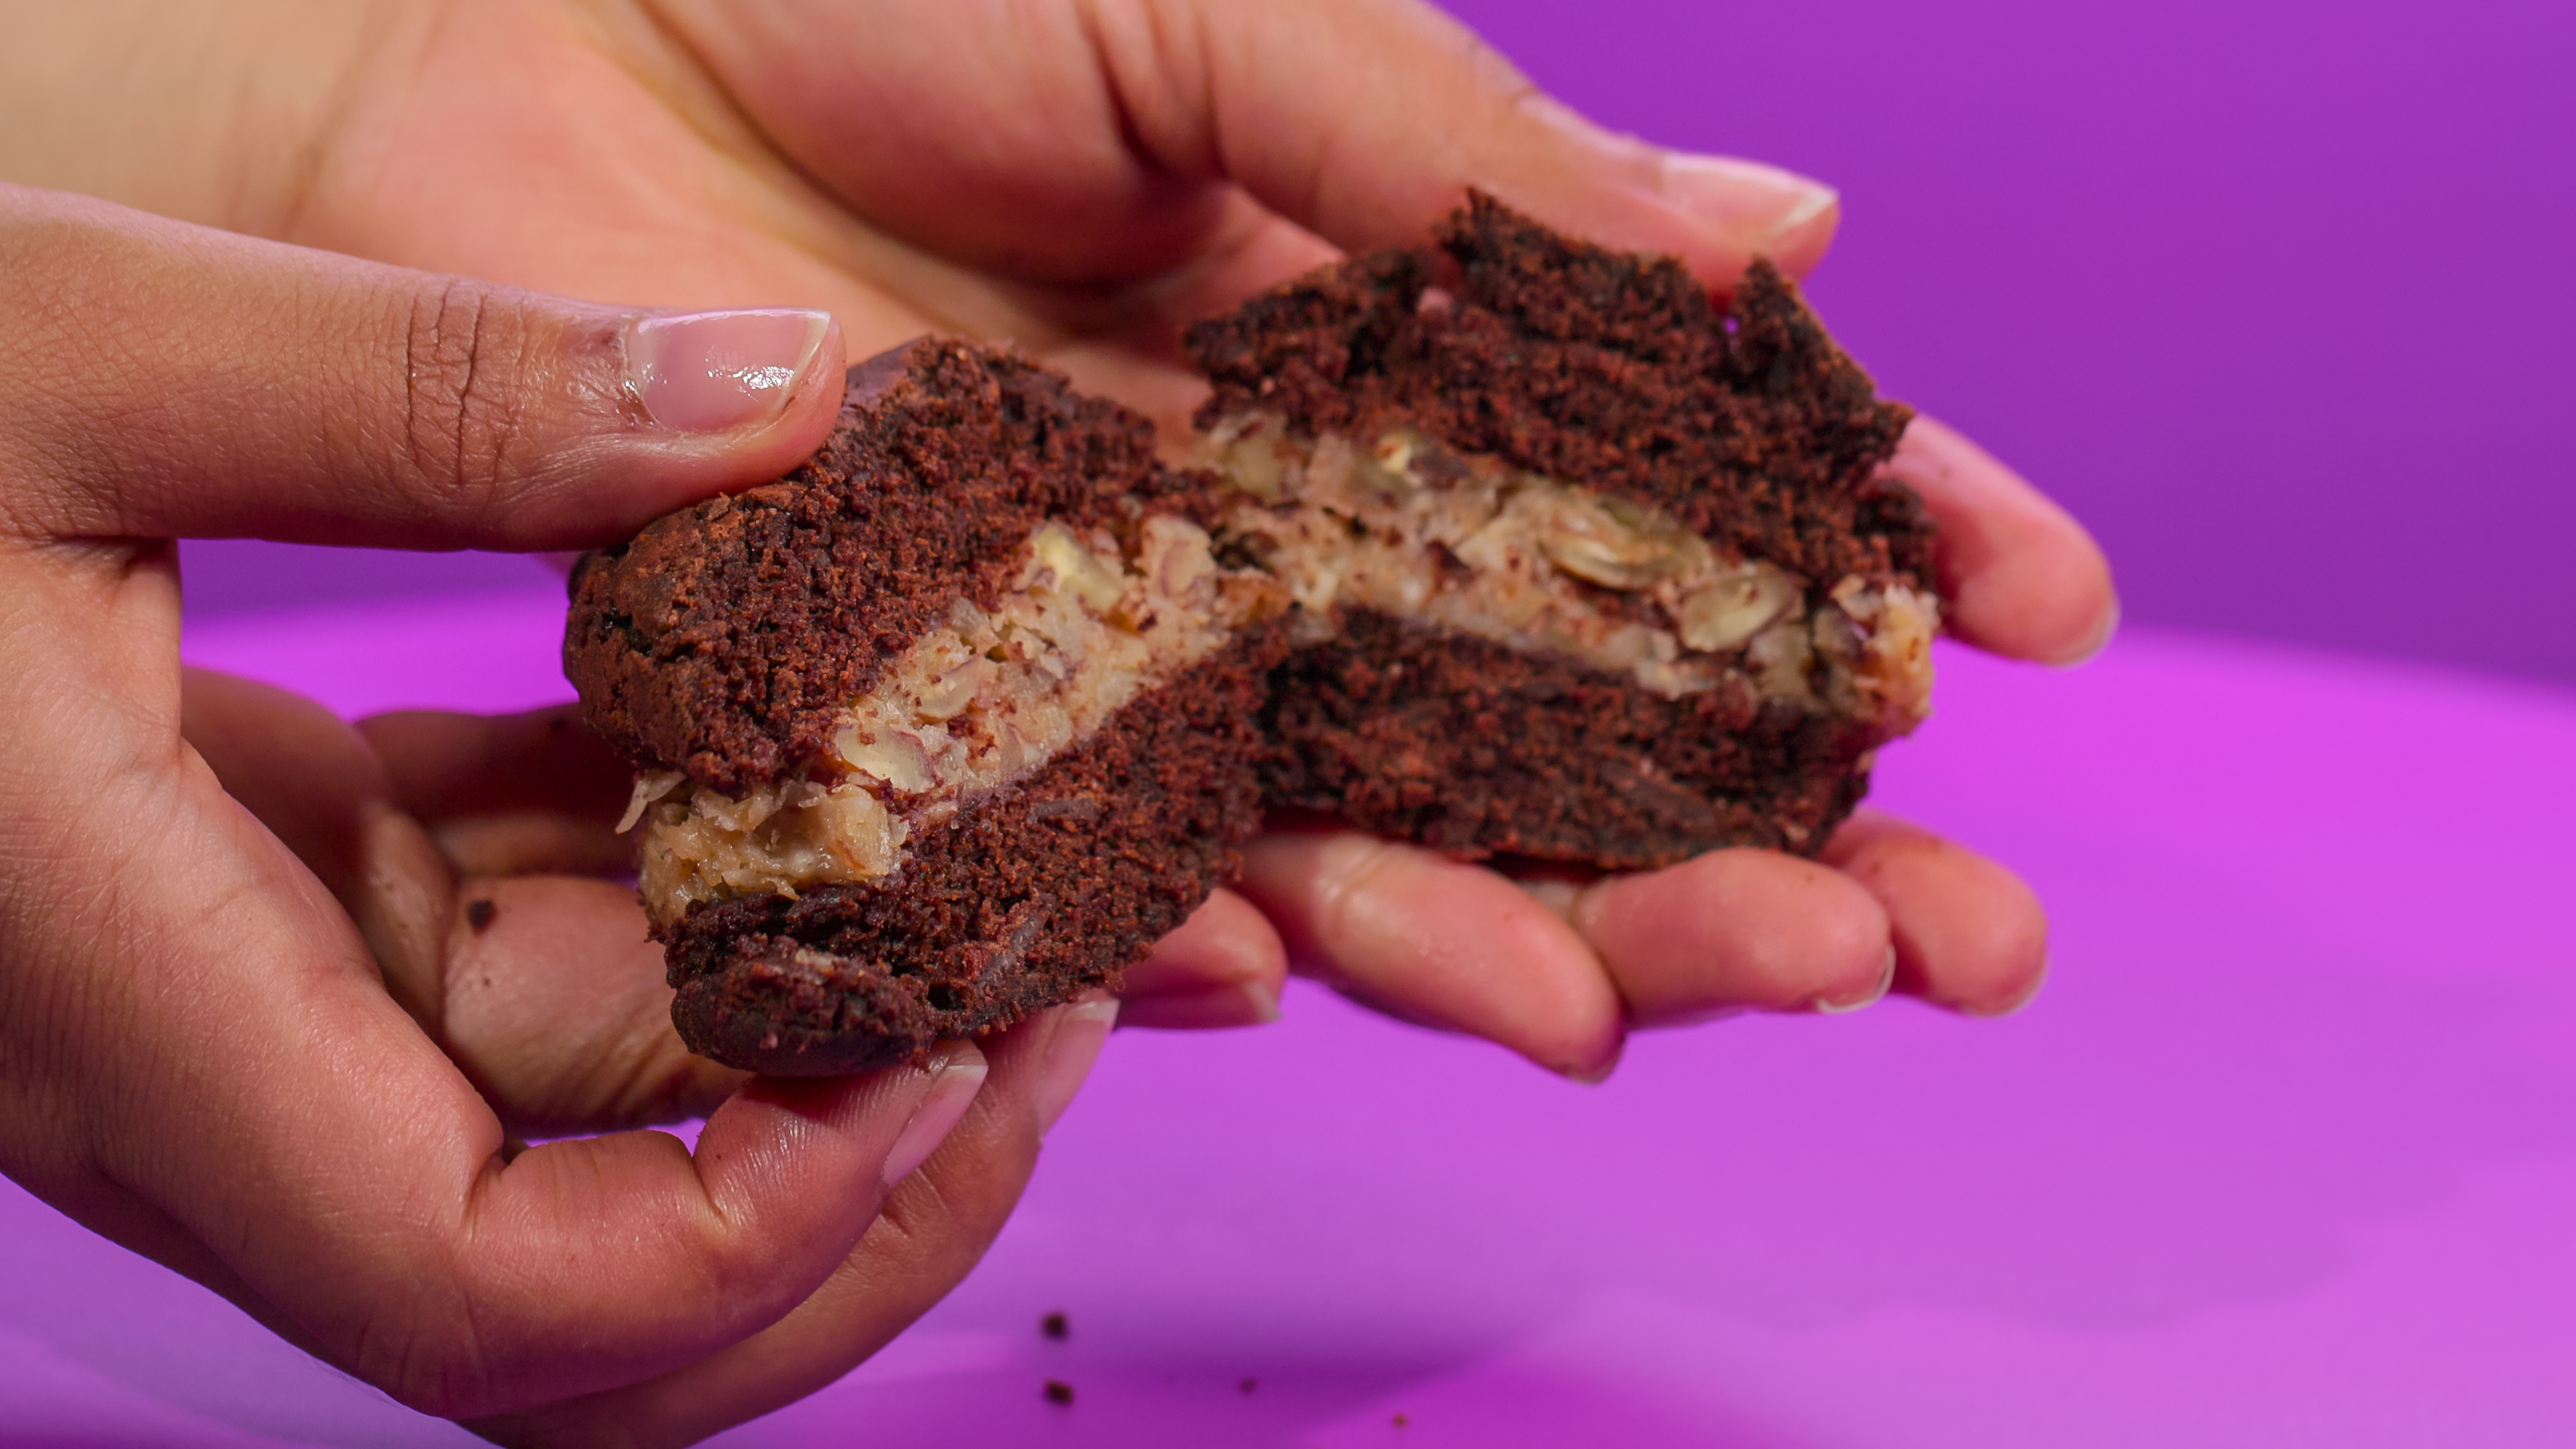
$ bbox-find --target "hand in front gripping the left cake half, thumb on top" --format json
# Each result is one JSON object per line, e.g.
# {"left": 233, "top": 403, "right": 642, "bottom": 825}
{"left": 0, "top": 189, "right": 1148, "bottom": 1444}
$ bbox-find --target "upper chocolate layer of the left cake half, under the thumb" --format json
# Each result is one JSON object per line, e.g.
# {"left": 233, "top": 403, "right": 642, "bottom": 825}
{"left": 564, "top": 337, "right": 1200, "bottom": 794}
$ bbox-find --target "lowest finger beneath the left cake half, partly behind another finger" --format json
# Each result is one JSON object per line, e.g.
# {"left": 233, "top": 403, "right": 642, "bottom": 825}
{"left": 472, "top": 989, "right": 1097, "bottom": 1449}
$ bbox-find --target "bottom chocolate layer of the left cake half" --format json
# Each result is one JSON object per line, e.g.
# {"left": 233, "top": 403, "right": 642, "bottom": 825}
{"left": 665, "top": 624, "right": 1280, "bottom": 1075}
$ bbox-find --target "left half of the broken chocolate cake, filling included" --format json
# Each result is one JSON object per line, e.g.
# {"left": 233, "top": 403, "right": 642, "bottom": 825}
{"left": 564, "top": 340, "right": 1285, "bottom": 1075}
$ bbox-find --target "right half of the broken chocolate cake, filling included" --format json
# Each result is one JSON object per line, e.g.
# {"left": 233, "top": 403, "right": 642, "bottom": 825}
{"left": 1187, "top": 196, "right": 1940, "bottom": 869}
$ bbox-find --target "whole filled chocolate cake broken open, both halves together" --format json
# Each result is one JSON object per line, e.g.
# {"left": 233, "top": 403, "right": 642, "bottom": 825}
{"left": 564, "top": 196, "right": 1937, "bottom": 1075}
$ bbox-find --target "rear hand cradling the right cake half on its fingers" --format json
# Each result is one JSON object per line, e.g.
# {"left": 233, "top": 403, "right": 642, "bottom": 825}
{"left": 0, "top": 0, "right": 2115, "bottom": 1057}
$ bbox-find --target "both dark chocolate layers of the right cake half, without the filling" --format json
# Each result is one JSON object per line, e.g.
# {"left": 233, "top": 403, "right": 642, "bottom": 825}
{"left": 1187, "top": 193, "right": 1932, "bottom": 869}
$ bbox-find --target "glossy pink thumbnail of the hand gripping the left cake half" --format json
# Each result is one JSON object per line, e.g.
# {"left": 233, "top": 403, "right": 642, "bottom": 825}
{"left": 626, "top": 307, "right": 832, "bottom": 433}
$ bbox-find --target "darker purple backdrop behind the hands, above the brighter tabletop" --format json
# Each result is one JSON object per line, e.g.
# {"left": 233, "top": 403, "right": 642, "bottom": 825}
{"left": 191, "top": 0, "right": 2576, "bottom": 681}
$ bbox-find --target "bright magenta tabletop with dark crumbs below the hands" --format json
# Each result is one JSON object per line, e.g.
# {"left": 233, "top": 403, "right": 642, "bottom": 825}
{"left": 0, "top": 588, "right": 2576, "bottom": 1449}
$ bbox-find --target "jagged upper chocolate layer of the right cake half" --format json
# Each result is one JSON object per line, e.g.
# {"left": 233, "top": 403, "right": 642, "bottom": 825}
{"left": 1187, "top": 193, "right": 1932, "bottom": 585}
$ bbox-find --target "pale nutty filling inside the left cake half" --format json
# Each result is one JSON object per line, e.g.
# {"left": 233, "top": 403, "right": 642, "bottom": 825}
{"left": 621, "top": 516, "right": 1285, "bottom": 926}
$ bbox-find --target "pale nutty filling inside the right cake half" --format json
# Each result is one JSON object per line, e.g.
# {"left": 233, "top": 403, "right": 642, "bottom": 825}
{"left": 1198, "top": 413, "right": 1940, "bottom": 735}
